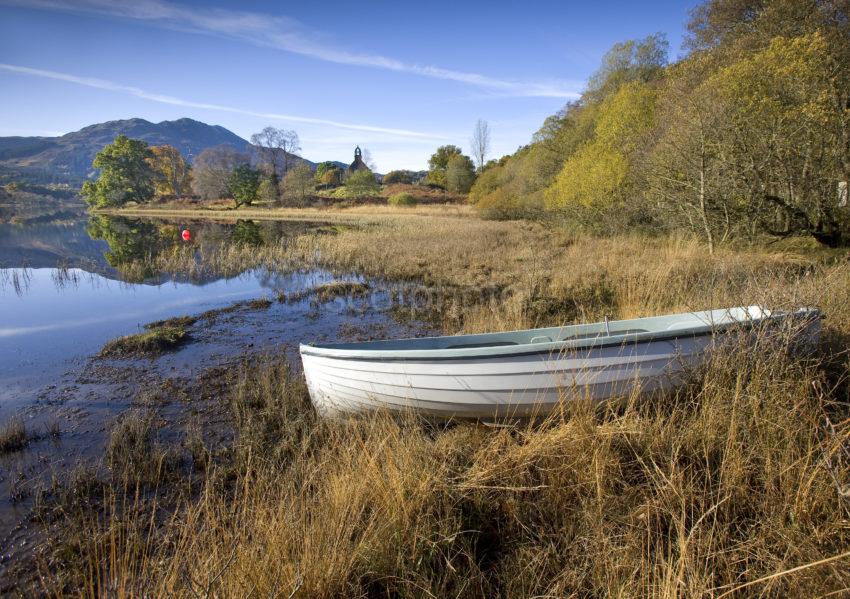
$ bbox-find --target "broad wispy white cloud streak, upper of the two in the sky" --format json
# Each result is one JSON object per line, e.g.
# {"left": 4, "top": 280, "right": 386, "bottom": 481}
{"left": 0, "top": 0, "right": 582, "bottom": 98}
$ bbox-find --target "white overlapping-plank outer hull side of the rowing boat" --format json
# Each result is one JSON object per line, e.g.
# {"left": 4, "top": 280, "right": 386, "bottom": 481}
{"left": 302, "top": 335, "right": 711, "bottom": 419}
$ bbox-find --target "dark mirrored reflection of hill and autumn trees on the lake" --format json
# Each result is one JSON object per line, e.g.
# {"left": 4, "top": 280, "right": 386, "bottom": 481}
{"left": 0, "top": 214, "right": 321, "bottom": 294}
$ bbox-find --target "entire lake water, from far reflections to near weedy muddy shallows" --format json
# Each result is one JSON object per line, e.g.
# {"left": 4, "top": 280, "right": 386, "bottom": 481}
{"left": 0, "top": 214, "right": 428, "bottom": 570}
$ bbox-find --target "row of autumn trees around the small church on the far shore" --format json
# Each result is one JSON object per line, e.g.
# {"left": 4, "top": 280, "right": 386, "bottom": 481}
{"left": 81, "top": 126, "right": 489, "bottom": 208}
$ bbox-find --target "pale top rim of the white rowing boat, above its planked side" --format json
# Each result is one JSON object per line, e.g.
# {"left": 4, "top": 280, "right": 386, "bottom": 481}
{"left": 299, "top": 306, "right": 822, "bottom": 362}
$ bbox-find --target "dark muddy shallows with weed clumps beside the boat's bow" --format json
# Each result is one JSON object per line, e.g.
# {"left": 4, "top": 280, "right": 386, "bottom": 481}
{"left": 0, "top": 275, "right": 435, "bottom": 594}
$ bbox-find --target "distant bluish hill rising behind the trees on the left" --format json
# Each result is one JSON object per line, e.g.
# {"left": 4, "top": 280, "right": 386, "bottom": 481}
{"left": 0, "top": 119, "right": 274, "bottom": 185}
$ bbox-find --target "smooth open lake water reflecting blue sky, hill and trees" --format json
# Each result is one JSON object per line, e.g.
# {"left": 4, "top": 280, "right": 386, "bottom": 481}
{"left": 0, "top": 216, "right": 350, "bottom": 417}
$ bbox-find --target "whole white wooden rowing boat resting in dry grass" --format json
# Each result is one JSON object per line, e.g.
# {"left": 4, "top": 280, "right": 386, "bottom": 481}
{"left": 300, "top": 306, "right": 820, "bottom": 419}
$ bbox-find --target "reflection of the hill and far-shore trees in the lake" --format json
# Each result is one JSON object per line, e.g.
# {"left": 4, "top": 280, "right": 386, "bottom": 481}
{"left": 0, "top": 212, "right": 326, "bottom": 285}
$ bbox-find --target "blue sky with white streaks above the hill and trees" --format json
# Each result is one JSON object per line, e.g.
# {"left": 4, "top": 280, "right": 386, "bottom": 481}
{"left": 0, "top": 0, "right": 696, "bottom": 172}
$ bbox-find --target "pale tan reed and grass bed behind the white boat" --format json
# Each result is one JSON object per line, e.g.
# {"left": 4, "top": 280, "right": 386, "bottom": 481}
{"left": 132, "top": 207, "right": 848, "bottom": 332}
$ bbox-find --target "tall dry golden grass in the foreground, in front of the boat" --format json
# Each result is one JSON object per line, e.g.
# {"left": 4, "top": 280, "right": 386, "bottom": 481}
{"left": 44, "top": 348, "right": 850, "bottom": 597}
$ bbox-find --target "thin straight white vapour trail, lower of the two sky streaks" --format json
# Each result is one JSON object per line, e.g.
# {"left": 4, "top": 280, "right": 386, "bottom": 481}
{"left": 0, "top": 63, "right": 444, "bottom": 140}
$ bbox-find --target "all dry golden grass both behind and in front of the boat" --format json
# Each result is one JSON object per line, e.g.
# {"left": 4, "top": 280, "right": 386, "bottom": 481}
{"left": 38, "top": 206, "right": 850, "bottom": 597}
